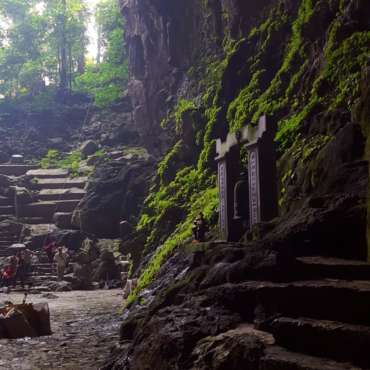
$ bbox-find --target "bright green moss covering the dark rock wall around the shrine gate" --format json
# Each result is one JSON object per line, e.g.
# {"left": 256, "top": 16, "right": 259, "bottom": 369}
{"left": 130, "top": 0, "right": 370, "bottom": 301}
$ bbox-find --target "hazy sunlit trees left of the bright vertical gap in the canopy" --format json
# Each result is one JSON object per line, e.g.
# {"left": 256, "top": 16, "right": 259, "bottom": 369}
{"left": 0, "top": 0, "right": 87, "bottom": 96}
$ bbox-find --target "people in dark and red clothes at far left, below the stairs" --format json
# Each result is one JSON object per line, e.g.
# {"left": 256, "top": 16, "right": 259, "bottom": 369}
{"left": 0, "top": 248, "right": 34, "bottom": 287}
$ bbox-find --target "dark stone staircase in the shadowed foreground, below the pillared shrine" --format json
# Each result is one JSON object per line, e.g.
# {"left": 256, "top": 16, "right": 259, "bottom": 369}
{"left": 243, "top": 257, "right": 370, "bottom": 370}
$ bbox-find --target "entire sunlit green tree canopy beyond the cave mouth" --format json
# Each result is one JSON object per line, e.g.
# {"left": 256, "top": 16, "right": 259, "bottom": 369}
{"left": 0, "top": 0, "right": 127, "bottom": 106}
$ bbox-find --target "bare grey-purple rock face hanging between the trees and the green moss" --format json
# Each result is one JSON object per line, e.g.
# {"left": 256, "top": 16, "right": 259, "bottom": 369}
{"left": 121, "top": 0, "right": 271, "bottom": 154}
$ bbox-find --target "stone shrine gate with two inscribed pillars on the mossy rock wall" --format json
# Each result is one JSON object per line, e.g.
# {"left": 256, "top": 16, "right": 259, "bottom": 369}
{"left": 216, "top": 116, "right": 278, "bottom": 241}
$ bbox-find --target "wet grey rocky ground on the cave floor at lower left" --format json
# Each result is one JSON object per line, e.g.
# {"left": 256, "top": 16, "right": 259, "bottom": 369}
{"left": 0, "top": 290, "right": 122, "bottom": 370}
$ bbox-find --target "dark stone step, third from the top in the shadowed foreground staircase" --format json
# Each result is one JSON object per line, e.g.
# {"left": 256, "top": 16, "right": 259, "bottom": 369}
{"left": 264, "top": 317, "right": 370, "bottom": 368}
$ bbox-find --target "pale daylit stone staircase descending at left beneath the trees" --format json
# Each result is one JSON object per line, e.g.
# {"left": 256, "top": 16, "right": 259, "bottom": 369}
{"left": 0, "top": 164, "right": 87, "bottom": 293}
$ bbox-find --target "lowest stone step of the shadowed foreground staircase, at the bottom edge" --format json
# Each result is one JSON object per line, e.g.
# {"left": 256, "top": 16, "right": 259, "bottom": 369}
{"left": 259, "top": 346, "right": 361, "bottom": 370}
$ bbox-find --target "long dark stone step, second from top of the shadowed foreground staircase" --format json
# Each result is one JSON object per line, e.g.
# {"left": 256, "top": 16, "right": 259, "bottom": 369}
{"left": 220, "top": 280, "right": 370, "bottom": 325}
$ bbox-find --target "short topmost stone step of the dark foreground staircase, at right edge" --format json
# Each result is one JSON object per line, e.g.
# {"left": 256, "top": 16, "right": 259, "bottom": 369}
{"left": 297, "top": 257, "right": 370, "bottom": 280}
